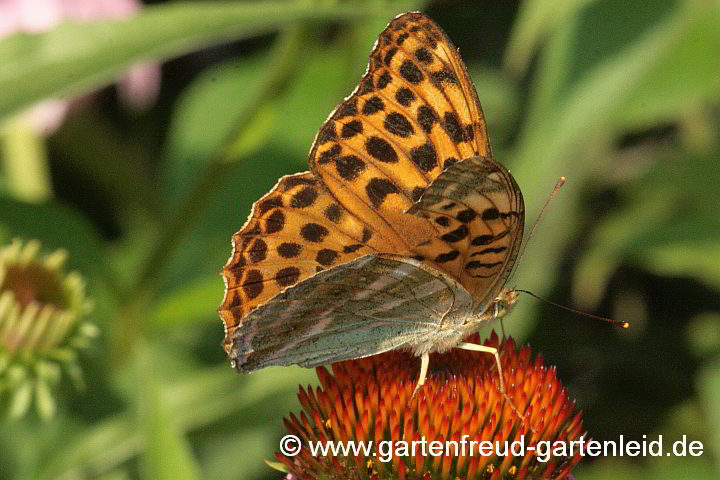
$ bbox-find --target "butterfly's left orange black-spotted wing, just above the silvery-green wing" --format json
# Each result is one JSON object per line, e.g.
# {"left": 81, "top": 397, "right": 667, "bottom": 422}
{"left": 219, "top": 172, "right": 376, "bottom": 349}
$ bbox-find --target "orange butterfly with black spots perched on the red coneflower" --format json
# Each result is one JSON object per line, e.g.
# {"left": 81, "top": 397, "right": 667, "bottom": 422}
{"left": 218, "top": 12, "right": 525, "bottom": 389}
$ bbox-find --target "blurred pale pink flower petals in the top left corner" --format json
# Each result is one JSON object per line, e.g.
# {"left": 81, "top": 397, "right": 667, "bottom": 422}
{"left": 0, "top": 0, "right": 160, "bottom": 134}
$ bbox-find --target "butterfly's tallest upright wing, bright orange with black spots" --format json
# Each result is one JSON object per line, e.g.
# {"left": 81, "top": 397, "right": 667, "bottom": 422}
{"left": 310, "top": 14, "right": 489, "bottom": 247}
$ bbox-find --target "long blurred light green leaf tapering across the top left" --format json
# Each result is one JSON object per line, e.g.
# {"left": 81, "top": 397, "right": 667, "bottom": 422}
{"left": 0, "top": 1, "right": 387, "bottom": 118}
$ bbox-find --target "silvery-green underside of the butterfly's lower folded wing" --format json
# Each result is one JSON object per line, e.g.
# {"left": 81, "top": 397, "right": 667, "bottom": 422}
{"left": 230, "top": 254, "right": 472, "bottom": 371}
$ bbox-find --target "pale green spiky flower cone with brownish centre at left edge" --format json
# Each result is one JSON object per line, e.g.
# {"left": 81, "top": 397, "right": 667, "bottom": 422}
{"left": 0, "top": 240, "right": 98, "bottom": 418}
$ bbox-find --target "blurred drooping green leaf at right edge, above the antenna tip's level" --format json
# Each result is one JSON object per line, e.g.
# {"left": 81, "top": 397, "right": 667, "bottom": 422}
{"left": 573, "top": 142, "right": 720, "bottom": 309}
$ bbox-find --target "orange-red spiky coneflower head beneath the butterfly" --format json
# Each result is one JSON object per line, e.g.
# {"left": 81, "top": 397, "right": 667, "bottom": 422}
{"left": 276, "top": 332, "right": 584, "bottom": 480}
